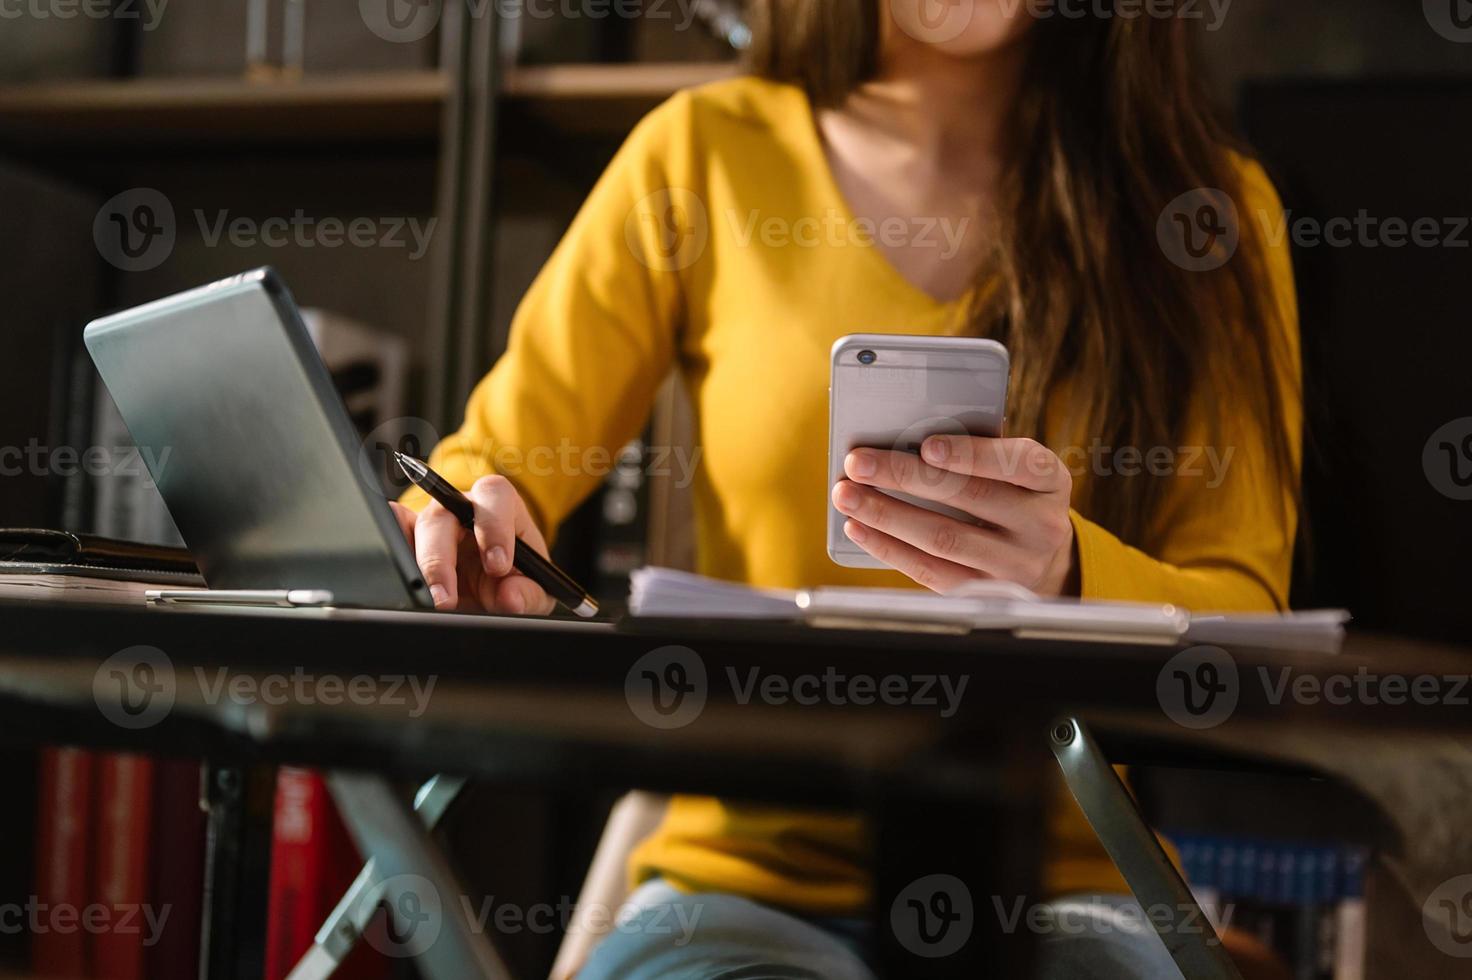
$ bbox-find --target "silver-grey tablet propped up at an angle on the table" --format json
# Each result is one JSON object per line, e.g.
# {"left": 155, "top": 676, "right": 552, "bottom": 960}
{"left": 84, "top": 269, "right": 434, "bottom": 609}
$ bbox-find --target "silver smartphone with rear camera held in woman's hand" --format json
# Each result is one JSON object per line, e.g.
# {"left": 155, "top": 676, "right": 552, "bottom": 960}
{"left": 827, "top": 334, "right": 1010, "bottom": 568}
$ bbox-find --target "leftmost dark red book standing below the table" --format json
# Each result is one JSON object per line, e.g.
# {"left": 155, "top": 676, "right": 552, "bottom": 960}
{"left": 31, "top": 748, "right": 94, "bottom": 977}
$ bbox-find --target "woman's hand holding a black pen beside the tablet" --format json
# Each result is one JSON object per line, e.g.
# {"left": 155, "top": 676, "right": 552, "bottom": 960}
{"left": 389, "top": 477, "right": 556, "bottom": 615}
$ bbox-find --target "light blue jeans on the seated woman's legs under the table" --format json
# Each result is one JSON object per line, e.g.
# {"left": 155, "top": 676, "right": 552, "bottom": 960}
{"left": 577, "top": 880, "right": 1181, "bottom": 980}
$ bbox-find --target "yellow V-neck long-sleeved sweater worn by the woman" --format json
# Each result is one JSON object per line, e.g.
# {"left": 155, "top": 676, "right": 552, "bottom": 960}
{"left": 406, "top": 78, "right": 1298, "bottom": 914}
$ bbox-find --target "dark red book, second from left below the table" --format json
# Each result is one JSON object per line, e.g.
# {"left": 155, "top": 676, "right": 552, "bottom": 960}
{"left": 91, "top": 752, "right": 156, "bottom": 980}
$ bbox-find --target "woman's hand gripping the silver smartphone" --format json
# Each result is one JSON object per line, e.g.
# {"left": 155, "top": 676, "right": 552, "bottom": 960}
{"left": 833, "top": 436, "right": 1078, "bottom": 596}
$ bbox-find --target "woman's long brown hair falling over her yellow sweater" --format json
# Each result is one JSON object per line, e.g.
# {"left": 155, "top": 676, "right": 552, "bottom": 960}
{"left": 751, "top": 0, "right": 1297, "bottom": 549}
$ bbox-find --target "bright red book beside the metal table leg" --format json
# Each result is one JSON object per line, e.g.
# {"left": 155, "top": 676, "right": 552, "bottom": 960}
{"left": 265, "top": 768, "right": 389, "bottom": 980}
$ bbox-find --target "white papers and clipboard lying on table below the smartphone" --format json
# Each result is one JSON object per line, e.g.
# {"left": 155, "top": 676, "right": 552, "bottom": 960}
{"left": 629, "top": 568, "right": 1350, "bottom": 653}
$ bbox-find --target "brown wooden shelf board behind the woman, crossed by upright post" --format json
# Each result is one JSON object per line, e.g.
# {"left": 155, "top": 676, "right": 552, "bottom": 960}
{"left": 0, "top": 63, "right": 735, "bottom": 149}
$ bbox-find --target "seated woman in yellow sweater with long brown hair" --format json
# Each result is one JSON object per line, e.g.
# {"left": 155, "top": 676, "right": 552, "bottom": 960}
{"left": 399, "top": 0, "right": 1300, "bottom": 977}
